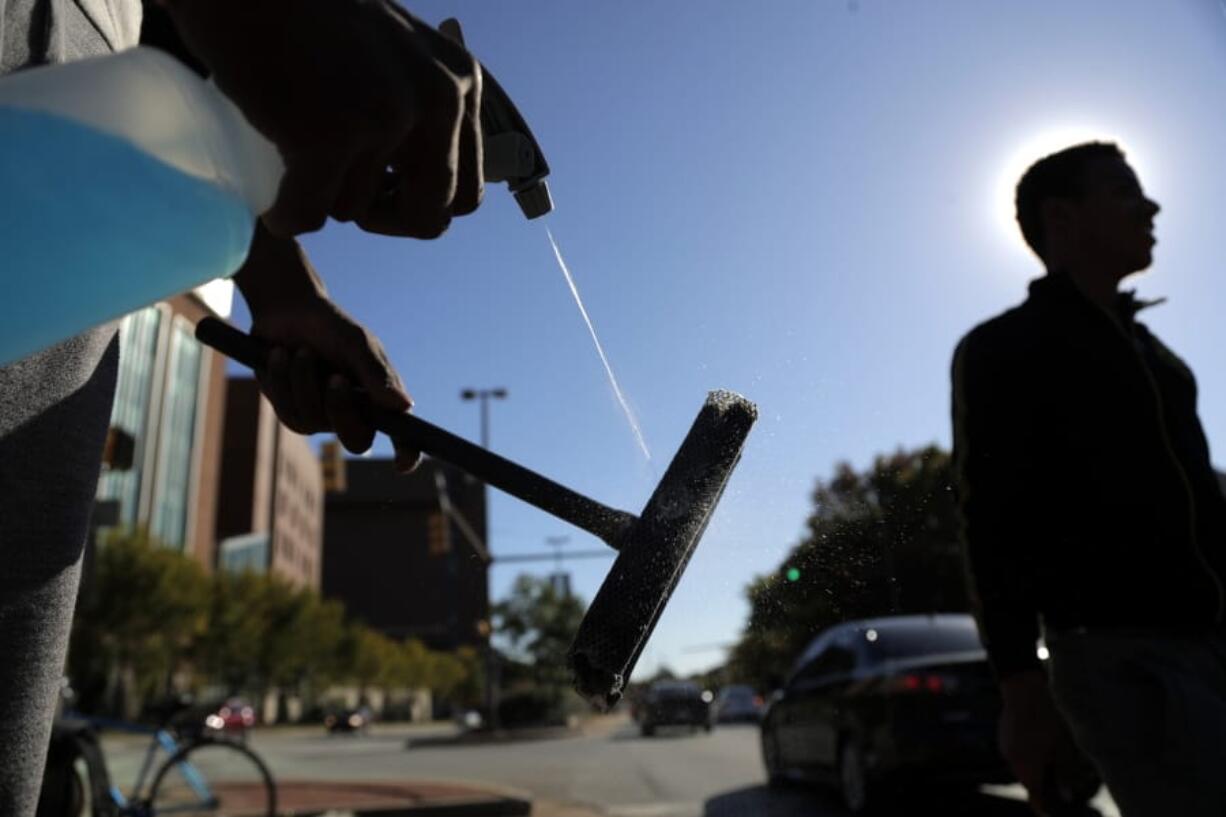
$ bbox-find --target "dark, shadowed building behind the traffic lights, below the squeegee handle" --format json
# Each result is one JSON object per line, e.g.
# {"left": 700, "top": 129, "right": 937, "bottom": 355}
{"left": 322, "top": 459, "right": 489, "bottom": 650}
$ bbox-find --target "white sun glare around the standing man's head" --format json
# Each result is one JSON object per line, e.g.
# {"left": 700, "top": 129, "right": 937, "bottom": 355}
{"left": 991, "top": 123, "right": 1154, "bottom": 249}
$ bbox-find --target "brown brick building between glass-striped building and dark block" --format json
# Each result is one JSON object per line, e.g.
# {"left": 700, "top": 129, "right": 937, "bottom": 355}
{"left": 216, "top": 378, "right": 324, "bottom": 590}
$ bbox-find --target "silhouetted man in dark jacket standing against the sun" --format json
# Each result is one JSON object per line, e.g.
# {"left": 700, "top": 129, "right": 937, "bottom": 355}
{"left": 953, "top": 142, "right": 1226, "bottom": 817}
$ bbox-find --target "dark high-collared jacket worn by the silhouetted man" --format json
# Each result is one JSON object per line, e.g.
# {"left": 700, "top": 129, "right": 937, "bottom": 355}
{"left": 953, "top": 274, "right": 1226, "bottom": 676}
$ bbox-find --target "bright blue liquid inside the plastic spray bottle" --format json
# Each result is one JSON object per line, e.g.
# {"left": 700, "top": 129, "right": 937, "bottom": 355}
{"left": 0, "top": 105, "right": 255, "bottom": 366}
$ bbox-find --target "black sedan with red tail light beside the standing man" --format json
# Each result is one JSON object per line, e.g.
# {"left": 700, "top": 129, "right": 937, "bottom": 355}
{"left": 761, "top": 615, "right": 1098, "bottom": 813}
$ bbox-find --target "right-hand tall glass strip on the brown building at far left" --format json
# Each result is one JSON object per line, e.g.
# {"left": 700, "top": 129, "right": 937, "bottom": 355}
{"left": 150, "top": 318, "right": 201, "bottom": 550}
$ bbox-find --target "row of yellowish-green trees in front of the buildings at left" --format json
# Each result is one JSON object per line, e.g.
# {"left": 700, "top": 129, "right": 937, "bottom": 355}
{"left": 70, "top": 531, "right": 479, "bottom": 708}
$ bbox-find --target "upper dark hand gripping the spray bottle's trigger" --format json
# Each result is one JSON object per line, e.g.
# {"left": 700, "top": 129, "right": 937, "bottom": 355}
{"left": 163, "top": 0, "right": 483, "bottom": 238}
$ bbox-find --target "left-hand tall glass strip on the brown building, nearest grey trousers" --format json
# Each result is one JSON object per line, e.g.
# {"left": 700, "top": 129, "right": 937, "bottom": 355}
{"left": 98, "top": 307, "right": 162, "bottom": 525}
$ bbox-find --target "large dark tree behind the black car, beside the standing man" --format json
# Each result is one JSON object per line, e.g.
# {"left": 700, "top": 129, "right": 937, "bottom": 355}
{"left": 731, "top": 447, "right": 969, "bottom": 687}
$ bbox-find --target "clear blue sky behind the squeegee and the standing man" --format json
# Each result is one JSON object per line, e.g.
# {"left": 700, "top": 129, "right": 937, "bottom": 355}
{"left": 230, "top": 0, "right": 1226, "bottom": 673}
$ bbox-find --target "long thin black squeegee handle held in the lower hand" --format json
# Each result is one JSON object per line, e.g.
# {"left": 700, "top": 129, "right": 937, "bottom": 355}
{"left": 196, "top": 318, "right": 635, "bottom": 548}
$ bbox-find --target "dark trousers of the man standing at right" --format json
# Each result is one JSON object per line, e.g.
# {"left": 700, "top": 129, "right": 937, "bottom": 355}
{"left": 1047, "top": 632, "right": 1226, "bottom": 817}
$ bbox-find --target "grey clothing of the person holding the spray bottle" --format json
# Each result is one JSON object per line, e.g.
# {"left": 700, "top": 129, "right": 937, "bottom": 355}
{"left": 0, "top": 0, "right": 141, "bottom": 817}
